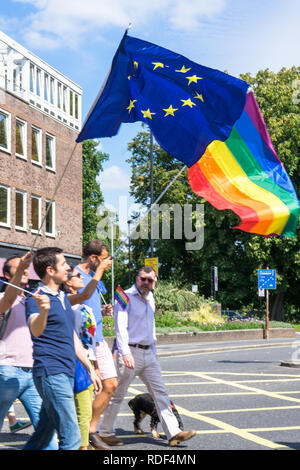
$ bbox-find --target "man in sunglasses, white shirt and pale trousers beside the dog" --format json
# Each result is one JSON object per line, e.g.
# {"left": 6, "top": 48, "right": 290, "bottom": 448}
{"left": 99, "top": 266, "right": 196, "bottom": 446}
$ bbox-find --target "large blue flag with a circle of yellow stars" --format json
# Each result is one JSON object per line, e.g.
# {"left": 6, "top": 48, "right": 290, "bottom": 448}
{"left": 76, "top": 32, "right": 248, "bottom": 167}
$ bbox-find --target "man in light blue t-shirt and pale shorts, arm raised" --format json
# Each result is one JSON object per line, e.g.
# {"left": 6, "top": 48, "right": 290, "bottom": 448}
{"left": 75, "top": 239, "right": 122, "bottom": 450}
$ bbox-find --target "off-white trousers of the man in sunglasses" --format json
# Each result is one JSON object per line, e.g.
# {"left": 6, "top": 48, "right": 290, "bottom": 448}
{"left": 99, "top": 347, "right": 181, "bottom": 439}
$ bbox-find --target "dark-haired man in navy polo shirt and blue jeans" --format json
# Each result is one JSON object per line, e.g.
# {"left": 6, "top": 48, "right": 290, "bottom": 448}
{"left": 24, "top": 248, "right": 101, "bottom": 450}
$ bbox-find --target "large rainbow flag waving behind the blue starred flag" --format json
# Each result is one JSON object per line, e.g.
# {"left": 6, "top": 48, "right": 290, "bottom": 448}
{"left": 188, "top": 91, "right": 300, "bottom": 237}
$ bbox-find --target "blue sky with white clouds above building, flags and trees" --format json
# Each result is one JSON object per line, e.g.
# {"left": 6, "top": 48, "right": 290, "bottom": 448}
{"left": 0, "top": 0, "right": 300, "bottom": 222}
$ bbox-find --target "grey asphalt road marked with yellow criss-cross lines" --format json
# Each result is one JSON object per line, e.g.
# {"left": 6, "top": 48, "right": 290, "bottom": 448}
{"left": 0, "top": 338, "right": 300, "bottom": 463}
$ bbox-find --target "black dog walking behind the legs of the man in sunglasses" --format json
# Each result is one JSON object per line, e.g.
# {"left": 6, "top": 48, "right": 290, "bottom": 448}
{"left": 128, "top": 393, "right": 183, "bottom": 437}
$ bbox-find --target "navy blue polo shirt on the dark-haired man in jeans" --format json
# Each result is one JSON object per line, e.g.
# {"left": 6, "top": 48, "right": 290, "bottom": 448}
{"left": 26, "top": 290, "right": 76, "bottom": 377}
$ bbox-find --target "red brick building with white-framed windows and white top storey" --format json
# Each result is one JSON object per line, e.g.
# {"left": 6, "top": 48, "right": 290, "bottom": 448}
{"left": 0, "top": 31, "right": 82, "bottom": 279}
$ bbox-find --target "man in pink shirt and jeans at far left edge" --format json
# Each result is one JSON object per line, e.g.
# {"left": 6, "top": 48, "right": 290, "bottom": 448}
{"left": 0, "top": 252, "right": 53, "bottom": 450}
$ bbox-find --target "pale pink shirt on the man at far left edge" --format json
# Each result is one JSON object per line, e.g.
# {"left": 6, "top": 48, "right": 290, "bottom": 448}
{"left": 0, "top": 292, "right": 33, "bottom": 367}
